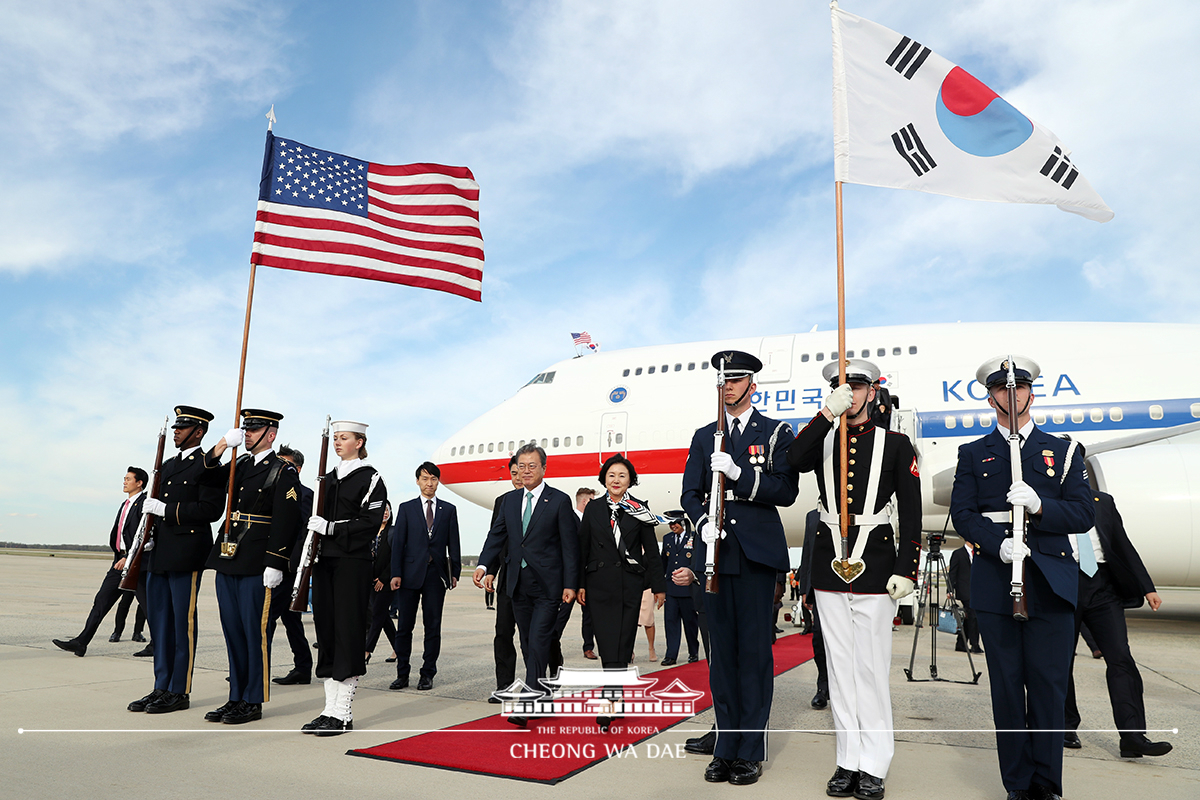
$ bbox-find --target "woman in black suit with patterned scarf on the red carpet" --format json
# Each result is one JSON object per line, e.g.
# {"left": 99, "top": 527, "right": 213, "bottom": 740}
{"left": 580, "top": 455, "right": 666, "bottom": 669}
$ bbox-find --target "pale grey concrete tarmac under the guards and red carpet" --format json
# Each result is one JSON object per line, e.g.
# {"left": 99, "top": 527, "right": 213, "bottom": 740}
{"left": 0, "top": 553, "right": 1200, "bottom": 800}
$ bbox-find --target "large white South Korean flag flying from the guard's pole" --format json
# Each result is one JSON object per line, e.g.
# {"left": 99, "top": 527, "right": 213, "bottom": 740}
{"left": 833, "top": 4, "right": 1112, "bottom": 222}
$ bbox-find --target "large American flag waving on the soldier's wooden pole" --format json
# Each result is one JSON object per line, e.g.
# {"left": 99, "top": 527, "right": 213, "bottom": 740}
{"left": 251, "top": 132, "right": 484, "bottom": 300}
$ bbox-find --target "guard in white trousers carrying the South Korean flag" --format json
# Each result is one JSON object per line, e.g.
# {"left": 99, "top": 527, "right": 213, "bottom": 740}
{"left": 787, "top": 359, "right": 920, "bottom": 800}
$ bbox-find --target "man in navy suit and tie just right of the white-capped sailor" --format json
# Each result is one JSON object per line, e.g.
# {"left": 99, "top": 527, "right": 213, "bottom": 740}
{"left": 389, "top": 462, "right": 462, "bottom": 691}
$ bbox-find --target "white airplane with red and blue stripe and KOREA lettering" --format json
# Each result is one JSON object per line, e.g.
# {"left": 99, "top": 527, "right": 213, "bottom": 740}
{"left": 434, "top": 323, "right": 1200, "bottom": 587}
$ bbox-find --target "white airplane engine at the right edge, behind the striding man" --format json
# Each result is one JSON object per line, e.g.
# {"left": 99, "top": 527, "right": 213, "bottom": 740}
{"left": 1087, "top": 440, "right": 1200, "bottom": 587}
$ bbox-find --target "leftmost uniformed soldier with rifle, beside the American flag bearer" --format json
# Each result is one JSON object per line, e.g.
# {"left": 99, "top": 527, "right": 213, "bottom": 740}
{"left": 128, "top": 405, "right": 229, "bottom": 714}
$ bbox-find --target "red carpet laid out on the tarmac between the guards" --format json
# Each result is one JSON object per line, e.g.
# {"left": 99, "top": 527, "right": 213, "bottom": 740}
{"left": 347, "top": 634, "right": 812, "bottom": 784}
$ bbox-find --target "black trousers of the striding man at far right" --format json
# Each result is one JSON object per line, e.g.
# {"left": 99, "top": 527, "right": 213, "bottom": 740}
{"left": 1067, "top": 564, "right": 1146, "bottom": 733}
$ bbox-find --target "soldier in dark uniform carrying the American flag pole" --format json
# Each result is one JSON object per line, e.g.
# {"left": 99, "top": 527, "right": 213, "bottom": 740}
{"left": 204, "top": 409, "right": 302, "bottom": 724}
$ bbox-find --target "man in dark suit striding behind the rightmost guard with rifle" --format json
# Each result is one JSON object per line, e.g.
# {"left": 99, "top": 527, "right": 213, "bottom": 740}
{"left": 1064, "top": 491, "right": 1171, "bottom": 758}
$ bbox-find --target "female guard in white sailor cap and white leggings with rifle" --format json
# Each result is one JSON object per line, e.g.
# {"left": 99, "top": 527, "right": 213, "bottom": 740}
{"left": 300, "top": 420, "right": 388, "bottom": 736}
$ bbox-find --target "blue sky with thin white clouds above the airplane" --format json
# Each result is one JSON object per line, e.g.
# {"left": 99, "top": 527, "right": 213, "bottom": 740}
{"left": 0, "top": 0, "right": 1200, "bottom": 552}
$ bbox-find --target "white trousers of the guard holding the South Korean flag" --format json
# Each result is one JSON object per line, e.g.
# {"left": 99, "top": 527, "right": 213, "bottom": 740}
{"left": 816, "top": 590, "right": 895, "bottom": 778}
